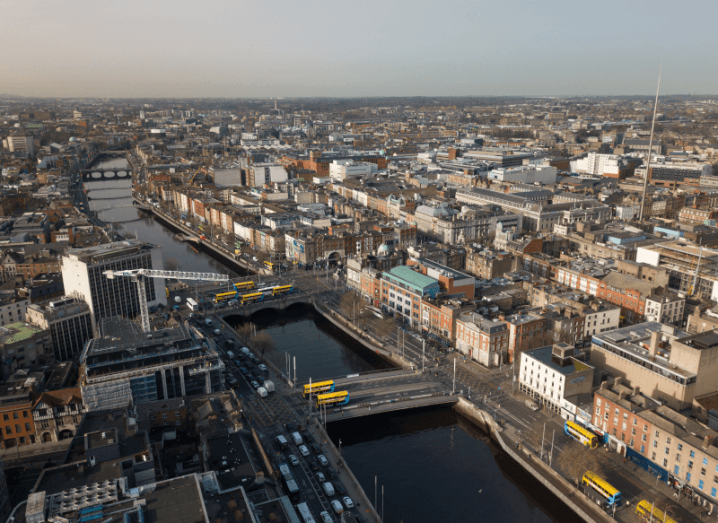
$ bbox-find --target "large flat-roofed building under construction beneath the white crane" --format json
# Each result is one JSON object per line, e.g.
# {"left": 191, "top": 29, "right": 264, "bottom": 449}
{"left": 80, "top": 318, "right": 225, "bottom": 411}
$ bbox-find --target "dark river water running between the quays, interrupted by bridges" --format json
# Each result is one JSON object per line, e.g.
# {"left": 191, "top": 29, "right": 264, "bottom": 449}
{"left": 85, "top": 160, "right": 577, "bottom": 523}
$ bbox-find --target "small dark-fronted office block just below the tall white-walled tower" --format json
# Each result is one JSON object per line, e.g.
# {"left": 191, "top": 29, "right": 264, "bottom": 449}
{"left": 26, "top": 297, "right": 97, "bottom": 361}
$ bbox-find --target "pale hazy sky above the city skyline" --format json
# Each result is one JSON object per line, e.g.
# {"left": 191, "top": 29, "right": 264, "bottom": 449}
{"left": 0, "top": 0, "right": 718, "bottom": 97}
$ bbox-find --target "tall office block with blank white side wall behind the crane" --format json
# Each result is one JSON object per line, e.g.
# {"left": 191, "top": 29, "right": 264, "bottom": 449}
{"left": 62, "top": 240, "right": 167, "bottom": 321}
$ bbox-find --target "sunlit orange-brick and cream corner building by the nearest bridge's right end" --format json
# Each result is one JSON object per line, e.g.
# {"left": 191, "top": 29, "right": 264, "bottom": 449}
{"left": 456, "top": 312, "right": 509, "bottom": 367}
